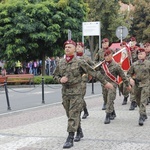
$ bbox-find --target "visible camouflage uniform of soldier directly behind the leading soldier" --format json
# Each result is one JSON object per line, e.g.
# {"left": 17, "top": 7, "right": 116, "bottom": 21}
{"left": 77, "top": 54, "right": 94, "bottom": 119}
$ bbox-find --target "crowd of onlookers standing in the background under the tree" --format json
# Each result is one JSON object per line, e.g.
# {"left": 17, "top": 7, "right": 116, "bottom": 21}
{"left": 0, "top": 57, "right": 59, "bottom": 76}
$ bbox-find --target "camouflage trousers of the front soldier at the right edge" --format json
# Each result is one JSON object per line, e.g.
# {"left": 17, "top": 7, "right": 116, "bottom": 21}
{"left": 134, "top": 84, "right": 149, "bottom": 115}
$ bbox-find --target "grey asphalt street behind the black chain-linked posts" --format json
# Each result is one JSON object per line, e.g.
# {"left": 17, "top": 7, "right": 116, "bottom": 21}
{"left": 0, "top": 82, "right": 101, "bottom": 114}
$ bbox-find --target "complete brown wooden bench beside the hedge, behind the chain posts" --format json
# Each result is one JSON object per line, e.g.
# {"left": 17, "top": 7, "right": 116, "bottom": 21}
{"left": 6, "top": 74, "right": 34, "bottom": 85}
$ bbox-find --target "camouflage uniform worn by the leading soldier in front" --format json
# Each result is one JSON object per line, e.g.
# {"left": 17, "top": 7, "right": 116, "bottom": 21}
{"left": 54, "top": 57, "right": 107, "bottom": 132}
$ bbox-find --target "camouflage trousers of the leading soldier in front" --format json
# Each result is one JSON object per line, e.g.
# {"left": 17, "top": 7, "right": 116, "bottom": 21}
{"left": 62, "top": 95, "right": 83, "bottom": 132}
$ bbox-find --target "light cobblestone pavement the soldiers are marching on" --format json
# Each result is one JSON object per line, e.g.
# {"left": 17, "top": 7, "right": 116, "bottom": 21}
{"left": 0, "top": 93, "right": 150, "bottom": 150}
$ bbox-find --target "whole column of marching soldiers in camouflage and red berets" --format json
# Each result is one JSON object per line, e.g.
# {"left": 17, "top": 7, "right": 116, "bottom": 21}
{"left": 53, "top": 38, "right": 150, "bottom": 148}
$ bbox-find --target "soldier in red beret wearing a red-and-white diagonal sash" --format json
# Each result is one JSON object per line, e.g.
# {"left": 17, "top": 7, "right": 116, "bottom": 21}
{"left": 99, "top": 50, "right": 131, "bottom": 124}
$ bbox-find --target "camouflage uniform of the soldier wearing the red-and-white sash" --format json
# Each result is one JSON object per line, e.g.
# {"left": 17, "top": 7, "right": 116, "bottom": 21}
{"left": 100, "top": 60, "right": 129, "bottom": 124}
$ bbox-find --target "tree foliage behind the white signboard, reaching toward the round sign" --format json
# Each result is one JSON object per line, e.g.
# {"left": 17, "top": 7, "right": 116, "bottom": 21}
{"left": 86, "top": 0, "right": 128, "bottom": 58}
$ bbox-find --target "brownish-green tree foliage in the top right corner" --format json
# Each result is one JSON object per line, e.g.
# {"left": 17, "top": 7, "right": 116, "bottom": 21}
{"left": 131, "top": 0, "right": 150, "bottom": 42}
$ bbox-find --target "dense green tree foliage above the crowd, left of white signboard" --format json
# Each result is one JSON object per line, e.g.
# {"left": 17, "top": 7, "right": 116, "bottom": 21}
{"left": 0, "top": 0, "right": 87, "bottom": 74}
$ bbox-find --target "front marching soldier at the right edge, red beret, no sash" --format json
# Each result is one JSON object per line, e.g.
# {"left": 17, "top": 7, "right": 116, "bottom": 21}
{"left": 128, "top": 48, "right": 150, "bottom": 126}
